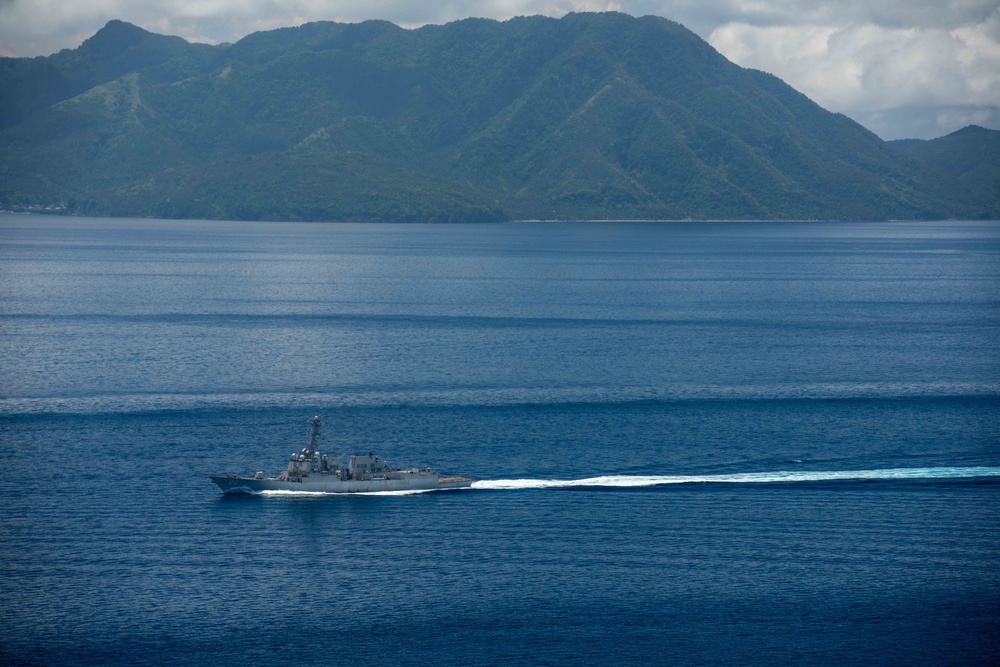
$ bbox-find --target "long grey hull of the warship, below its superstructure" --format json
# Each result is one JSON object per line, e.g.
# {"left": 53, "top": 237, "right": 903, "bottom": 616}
{"left": 212, "top": 475, "right": 472, "bottom": 494}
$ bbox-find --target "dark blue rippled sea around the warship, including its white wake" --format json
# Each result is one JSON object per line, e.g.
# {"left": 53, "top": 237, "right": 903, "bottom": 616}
{"left": 0, "top": 215, "right": 1000, "bottom": 666}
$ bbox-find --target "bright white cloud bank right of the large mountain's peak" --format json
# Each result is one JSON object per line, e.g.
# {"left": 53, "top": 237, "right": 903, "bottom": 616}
{"left": 708, "top": 12, "right": 1000, "bottom": 136}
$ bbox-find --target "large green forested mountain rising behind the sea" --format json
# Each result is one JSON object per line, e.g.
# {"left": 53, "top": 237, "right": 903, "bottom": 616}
{"left": 0, "top": 13, "right": 996, "bottom": 220}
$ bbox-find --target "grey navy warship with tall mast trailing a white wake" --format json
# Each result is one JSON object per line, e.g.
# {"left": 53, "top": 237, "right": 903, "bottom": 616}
{"left": 212, "top": 417, "right": 472, "bottom": 493}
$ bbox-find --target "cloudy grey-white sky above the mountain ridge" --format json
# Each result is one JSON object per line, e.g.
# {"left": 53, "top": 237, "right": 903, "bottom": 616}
{"left": 0, "top": 0, "right": 1000, "bottom": 139}
